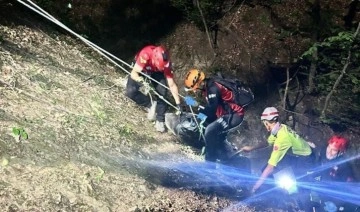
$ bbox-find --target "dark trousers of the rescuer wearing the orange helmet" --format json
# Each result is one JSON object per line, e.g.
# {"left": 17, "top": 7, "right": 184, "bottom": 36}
{"left": 205, "top": 114, "right": 244, "bottom": 162}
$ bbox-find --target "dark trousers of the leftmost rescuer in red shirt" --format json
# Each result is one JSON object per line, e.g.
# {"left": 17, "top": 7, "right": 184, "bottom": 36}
{"left": 126, "top": 72, "right": 168, "bottom": 122}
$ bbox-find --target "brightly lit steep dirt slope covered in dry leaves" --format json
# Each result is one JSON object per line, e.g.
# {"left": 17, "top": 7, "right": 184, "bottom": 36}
{"left": 0, "top": 23, "right": 264, "bottom": 211}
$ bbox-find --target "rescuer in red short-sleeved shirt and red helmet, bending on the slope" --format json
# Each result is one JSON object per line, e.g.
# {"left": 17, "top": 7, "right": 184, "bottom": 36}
{"left": 126, "top": 45, "right": 180, "bottom": 132}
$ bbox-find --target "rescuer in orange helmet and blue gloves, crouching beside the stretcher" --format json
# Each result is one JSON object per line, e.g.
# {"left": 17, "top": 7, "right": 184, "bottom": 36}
{"left": 185, "top": 69, "right": 244, "bottom": 162}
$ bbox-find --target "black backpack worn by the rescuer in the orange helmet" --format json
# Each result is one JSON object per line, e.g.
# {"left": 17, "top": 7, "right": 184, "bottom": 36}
{"left": 212, "top": 73, "right": 254, "bottom": 107}
